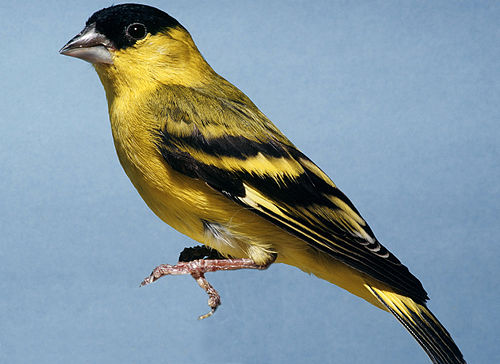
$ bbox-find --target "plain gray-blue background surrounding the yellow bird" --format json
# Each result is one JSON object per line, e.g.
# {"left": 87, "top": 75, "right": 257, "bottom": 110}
{"left": 0, "top": 0, "right": 500, "bottom": 363}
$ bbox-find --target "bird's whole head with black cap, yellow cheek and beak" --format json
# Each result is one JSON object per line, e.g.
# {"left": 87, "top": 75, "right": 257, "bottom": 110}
{"left": 59, "top": 4, "right": 213, "bottom": 92}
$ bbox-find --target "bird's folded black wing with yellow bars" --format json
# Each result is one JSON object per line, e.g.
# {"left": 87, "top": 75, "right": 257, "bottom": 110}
{"left": 157, "top": 86, "right": 427, "bottom": 303}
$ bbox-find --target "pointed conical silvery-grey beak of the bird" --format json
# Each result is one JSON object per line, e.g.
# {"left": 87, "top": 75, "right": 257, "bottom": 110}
{"left": 59, "top": 23, "right": 114, "bottom": 64}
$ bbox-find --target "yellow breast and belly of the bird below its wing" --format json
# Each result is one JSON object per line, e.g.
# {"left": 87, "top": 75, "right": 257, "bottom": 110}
{"left": 106, "top": 94, "right": 385, "bottom": 309}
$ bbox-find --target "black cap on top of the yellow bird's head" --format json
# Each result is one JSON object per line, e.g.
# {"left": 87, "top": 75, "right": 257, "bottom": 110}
{"left": 86, "top": 4, "right": 182, "bottom": 49}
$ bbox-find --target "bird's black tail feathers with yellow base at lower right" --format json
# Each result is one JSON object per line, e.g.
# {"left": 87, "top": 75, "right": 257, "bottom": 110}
{"left": 366, "top": 285, "right": 465, "bottom": 364}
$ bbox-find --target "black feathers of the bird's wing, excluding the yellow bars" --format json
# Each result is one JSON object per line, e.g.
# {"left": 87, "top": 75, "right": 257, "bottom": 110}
{"left": 158, "top": 126, "right": 428, "bottom": 303}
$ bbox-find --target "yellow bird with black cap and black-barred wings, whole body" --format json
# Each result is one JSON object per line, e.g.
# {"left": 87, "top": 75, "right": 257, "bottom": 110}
{"left": 59, "top": 4, "right": 465, "bottom": 363}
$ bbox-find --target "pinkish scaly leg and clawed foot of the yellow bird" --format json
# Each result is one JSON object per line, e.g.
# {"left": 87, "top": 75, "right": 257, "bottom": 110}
{"left": 141, "top": 246, "right": 274, "bottom": 320}
